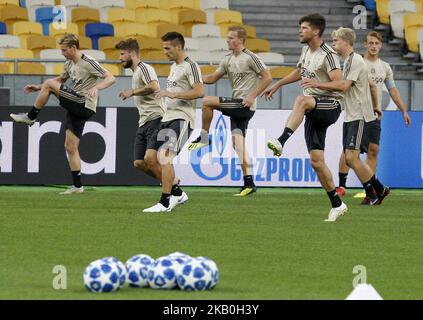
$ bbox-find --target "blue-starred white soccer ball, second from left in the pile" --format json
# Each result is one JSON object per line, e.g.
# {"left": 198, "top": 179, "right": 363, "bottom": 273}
{"left": 126, "top": 254, "right": 154, "bottom": 288}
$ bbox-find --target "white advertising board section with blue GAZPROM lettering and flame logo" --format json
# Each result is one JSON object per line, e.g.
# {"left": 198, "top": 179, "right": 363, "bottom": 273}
{"left": 175, "top": 110, "right": 361, "bottom": 187}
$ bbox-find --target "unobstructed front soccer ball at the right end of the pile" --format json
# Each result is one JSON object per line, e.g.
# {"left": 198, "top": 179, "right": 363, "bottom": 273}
{"left": 177, "top": 258, "right": 213, "bottom": 291}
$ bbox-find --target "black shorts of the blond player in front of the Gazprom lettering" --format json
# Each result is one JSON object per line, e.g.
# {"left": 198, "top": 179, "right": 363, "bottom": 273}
{"left": 217, "top": 97, "right": 255, "bottom": 137}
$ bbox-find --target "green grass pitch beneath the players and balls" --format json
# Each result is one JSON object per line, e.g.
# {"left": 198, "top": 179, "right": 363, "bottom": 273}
{"left": 0, "top": 186, "right": 423, "bottom": 300}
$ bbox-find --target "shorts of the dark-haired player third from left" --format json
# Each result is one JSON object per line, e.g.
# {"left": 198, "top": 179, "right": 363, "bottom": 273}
{"left": 154, "top": 119, "right": 192, "bottom": 155}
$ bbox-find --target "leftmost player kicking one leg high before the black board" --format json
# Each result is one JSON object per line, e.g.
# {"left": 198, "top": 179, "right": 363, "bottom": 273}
{"left": 10, "top": 34, "right": 115, "bottom": 195}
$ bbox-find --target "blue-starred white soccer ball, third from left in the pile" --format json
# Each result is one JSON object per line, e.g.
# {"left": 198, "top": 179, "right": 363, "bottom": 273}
{"left": 147, "top": 257, "right": 179, "bottom": 289}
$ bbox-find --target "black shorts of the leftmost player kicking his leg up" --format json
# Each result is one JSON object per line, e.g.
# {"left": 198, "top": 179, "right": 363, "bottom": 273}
{"left": 59, "top": 84, "right": 94, "bottom": 139}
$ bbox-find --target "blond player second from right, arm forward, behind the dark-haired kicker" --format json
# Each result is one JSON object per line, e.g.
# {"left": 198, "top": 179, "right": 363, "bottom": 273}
{"left": 303, "top": 28, "right": 390, "bottom": 205}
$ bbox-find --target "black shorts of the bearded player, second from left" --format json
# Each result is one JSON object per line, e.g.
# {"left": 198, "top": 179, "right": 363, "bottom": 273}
{"left": 134, "top": 118, "right": 162, "bottom": 160}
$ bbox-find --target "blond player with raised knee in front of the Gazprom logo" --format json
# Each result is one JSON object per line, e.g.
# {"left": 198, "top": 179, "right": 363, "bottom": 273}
{"left": 188, "top": 26, "right": 272, "bottom": 196}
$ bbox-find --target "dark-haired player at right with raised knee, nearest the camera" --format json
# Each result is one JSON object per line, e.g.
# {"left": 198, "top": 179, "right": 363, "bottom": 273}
{"left": 263, "top": 14, "right": 348, "bottom": 221}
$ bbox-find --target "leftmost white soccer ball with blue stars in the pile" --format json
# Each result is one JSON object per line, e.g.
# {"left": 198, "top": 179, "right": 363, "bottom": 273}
{"left": 83, "top": 258, "right": 120, "bottom": 292}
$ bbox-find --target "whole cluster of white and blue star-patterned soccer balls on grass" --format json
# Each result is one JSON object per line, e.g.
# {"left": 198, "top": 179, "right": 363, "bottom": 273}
{"left": 83, "top": 252, "right": 219, "bottom": 292}
